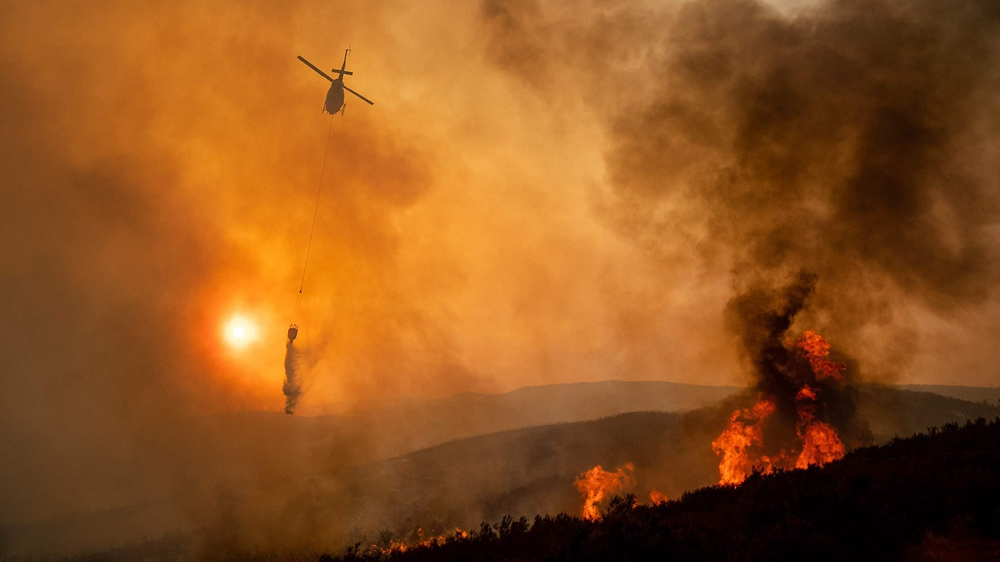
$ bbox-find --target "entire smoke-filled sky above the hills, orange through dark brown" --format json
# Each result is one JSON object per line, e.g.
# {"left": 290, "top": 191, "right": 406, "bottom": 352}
{"left": 0, "top": 0, "right": 1000, "bottom": 524}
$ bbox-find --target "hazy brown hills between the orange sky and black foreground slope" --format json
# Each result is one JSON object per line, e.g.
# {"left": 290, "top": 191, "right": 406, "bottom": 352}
{"left": 7, "top": 381, "right": 1000, "bottom": 554}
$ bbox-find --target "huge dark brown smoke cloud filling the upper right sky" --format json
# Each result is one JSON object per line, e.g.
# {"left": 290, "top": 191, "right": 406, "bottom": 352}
{"left": 610, "top": 2, "right": 1000, "bottom": 288}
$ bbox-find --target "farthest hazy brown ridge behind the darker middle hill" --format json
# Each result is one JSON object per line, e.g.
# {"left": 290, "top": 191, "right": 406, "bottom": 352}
{"left": 137, "top": 381, "right": 738, "bottom": 492}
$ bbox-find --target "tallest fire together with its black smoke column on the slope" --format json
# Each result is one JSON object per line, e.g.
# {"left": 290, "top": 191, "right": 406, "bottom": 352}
{"left": 712, "top": 272, "right": 871, "bottom": 484}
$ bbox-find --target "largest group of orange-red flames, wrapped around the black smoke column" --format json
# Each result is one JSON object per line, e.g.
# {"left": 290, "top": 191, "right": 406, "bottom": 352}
{"left": 712, "top": 330, "right": 847, "bottom": 485}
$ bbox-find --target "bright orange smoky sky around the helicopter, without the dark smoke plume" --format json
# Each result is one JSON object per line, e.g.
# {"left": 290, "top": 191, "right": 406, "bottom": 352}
{"left": 0, "top": 0, "right": 997, "bottom": 417}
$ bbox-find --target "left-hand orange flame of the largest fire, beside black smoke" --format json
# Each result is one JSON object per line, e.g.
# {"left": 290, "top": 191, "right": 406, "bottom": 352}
{"left": 712, "top": 397, "right": 774, "bottom": 485}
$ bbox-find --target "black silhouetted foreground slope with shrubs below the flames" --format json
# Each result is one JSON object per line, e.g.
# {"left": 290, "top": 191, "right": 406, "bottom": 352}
{"left": 332, "top": 418, "right": 1000, "bottom": 562}
